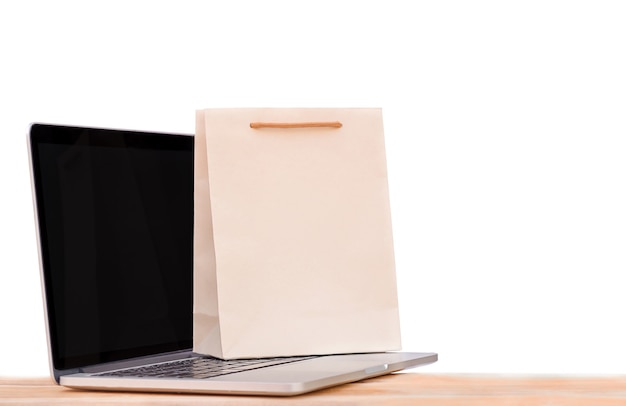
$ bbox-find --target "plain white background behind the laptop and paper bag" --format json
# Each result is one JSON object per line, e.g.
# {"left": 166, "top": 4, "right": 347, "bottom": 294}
{"left": 0, "top": 0, "right": 626, "bottom": 376}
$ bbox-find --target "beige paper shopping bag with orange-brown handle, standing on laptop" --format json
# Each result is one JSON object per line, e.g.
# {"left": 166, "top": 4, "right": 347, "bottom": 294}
{"left": 194, "top": 108, "right": 400, "bottom": 359}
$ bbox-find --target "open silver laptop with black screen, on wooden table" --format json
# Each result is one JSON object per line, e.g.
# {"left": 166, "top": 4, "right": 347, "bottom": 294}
{"left": 28, "top": 123, "right": 437, "bottom": 396}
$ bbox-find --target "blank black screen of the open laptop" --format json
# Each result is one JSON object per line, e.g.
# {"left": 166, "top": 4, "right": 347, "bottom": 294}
{"left": 30, "top": 124, "right": 193, "bottom": 369}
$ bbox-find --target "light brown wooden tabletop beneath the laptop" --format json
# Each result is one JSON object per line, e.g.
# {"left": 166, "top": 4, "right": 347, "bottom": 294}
{"left": 0, "top": 373, "right": 626, "bottom": 406}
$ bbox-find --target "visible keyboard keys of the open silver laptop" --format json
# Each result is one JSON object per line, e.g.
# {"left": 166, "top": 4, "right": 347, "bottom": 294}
{"left": 93, "top": 356, "right": 315, "bottom": 379}
